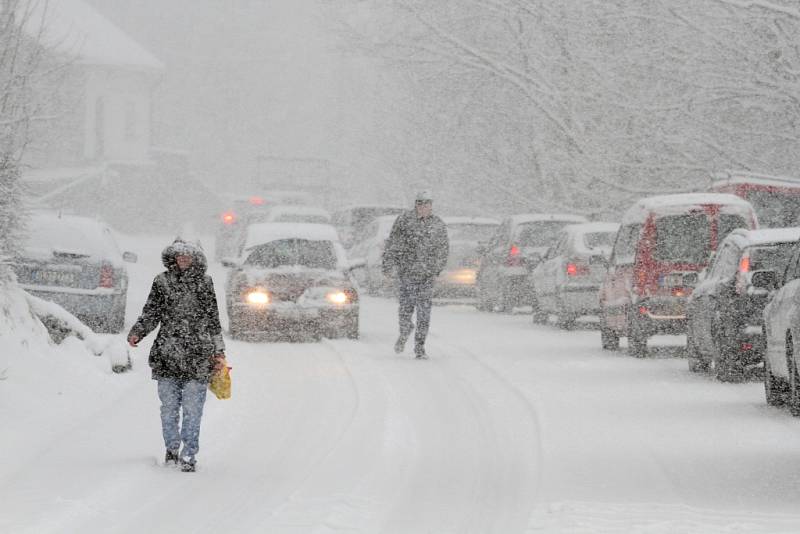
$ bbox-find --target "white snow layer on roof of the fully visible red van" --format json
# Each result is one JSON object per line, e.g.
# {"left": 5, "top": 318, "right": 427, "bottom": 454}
{"left": 622, "top": 193, "right": 756, "bottom": 224}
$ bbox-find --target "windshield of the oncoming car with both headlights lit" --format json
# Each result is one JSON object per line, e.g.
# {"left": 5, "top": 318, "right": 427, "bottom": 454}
{"left": 244, "top": 239, "right": 337, "bottom": 270}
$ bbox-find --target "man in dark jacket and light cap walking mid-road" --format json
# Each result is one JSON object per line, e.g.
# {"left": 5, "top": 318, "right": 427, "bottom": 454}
{"left": 383, "top": 191, "right": 450, "bottom": 359}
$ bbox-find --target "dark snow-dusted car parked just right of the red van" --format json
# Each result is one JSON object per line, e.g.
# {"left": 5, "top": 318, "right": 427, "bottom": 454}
{"left": 686, "top": 228, "right": 800, "bottom": 381}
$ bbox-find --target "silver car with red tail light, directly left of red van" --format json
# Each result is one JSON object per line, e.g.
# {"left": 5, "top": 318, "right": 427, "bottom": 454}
{"left": 531, "top": 222, "right": 619, "bottom": 328}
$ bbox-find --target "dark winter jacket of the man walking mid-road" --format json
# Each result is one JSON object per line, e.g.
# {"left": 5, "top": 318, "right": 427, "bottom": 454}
{"left": 383, "top": 210, "right": 450, "bottom": 280}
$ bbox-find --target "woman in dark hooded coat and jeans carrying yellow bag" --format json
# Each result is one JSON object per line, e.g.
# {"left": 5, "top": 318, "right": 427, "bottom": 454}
{"left": 128, "top": 238, "right": 225, "bottom": 472}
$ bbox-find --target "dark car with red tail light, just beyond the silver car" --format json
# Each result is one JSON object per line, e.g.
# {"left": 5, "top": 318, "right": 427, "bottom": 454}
{"left": 476, "top": 214, "right": 587, "bottom": 311}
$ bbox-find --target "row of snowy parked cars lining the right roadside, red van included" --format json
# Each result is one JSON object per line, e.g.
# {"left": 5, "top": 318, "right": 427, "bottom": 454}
{"left": 456, "top": 176, "right": 800, "bottom": 415}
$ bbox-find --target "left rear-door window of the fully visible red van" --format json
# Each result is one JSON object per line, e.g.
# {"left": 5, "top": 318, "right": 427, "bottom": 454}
{"left": 653, "top": 212, "right": 711, "bottom": 264}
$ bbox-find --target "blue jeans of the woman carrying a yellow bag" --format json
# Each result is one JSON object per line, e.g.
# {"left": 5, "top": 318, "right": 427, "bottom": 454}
{"left": 158, "top": 378, "right": 208, "bottom": 460}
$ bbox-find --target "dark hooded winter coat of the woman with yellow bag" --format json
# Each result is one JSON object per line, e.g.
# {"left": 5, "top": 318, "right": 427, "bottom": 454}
{"left": 128, "top": 240, "right": 225, "bottom": 382}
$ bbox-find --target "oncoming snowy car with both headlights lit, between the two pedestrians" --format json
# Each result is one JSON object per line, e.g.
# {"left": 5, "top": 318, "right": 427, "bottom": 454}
{"left": 224, "top": 223, "right": 359, "bottom": 339}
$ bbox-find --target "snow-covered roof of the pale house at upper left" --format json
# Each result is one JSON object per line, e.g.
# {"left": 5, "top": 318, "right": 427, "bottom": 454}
{"left": 22, "top": 0, "right": 164, "bottom": 71}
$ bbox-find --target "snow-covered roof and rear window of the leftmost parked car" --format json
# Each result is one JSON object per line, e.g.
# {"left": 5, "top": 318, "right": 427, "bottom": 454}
{"left": 22, "top": 213, "right": 122, "bottom": 265}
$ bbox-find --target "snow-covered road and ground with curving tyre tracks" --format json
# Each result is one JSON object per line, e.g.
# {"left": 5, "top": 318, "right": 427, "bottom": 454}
{"left": 0, "top": 238, "right": 800, "bottom": 534}
